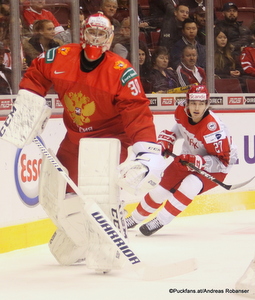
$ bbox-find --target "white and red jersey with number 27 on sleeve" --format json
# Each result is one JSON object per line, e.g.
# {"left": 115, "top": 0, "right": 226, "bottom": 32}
{"left": 172, "top": 102, "right": 237, "bottom": 173}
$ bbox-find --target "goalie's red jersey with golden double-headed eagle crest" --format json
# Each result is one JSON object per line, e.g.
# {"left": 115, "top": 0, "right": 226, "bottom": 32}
{"left": 20, "top": 44, "right": 156, "bottom": 144}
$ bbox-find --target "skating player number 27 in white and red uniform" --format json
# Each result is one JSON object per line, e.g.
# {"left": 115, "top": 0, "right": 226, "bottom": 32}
{"left": 126, "top": 85, "right": 237, "bottom": 236}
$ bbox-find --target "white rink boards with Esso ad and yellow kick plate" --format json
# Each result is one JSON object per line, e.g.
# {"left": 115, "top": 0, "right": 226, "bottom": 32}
{"left": 0, "top": 95, "right": 255, "bottom": 253}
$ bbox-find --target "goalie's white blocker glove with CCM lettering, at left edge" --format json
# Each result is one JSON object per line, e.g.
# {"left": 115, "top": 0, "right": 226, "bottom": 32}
{"left": 0, "top": 90, "right": 51, "bottom": 148}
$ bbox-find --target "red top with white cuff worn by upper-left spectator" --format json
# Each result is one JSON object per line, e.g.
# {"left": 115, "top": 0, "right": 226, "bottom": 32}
{"left": 23, "top": 7, "right": 64, "bottom": 34}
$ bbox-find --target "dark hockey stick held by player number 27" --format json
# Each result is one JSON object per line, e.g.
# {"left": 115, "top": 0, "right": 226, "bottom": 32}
{"left": 167, "top": 152, "right": 255, "bottom": 190}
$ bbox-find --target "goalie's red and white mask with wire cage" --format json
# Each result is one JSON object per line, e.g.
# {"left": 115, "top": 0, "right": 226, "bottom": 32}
{"left": 84, "top": 12, "right": 113, "bottom": 60}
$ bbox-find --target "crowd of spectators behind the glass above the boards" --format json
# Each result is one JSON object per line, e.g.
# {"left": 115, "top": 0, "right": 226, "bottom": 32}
{"left": 0, "top": 0, "right": 255, "bottom": 94}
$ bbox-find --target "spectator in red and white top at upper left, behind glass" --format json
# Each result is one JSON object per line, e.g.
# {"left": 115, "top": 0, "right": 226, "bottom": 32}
{"left": 23, "top": 0, "right": 71, "bottom": 43}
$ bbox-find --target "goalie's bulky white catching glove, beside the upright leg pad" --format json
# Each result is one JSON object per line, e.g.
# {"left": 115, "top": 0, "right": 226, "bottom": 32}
{"left": 118, "top": 142, "right": 166, "bottom": 195}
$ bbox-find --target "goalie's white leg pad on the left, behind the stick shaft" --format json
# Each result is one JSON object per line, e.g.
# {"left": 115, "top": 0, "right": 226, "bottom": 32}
{"left": 39, "top": 150, "right": 87, "bottom": 265}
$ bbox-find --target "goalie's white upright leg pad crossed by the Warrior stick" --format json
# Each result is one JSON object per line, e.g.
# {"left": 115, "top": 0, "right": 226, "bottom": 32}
{"left": 78, "top": 138, "right": 127, "bottom": 272}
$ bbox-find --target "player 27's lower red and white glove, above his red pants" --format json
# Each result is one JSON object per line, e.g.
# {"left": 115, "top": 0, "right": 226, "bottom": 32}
{"left": 174, "top": 154, "right": 206, "bottom": 172}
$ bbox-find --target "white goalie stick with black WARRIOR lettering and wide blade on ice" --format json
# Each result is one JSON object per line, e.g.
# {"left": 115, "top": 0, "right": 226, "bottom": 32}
{"left": 33, "top": 137, "right": 196, "bottom": 280}
